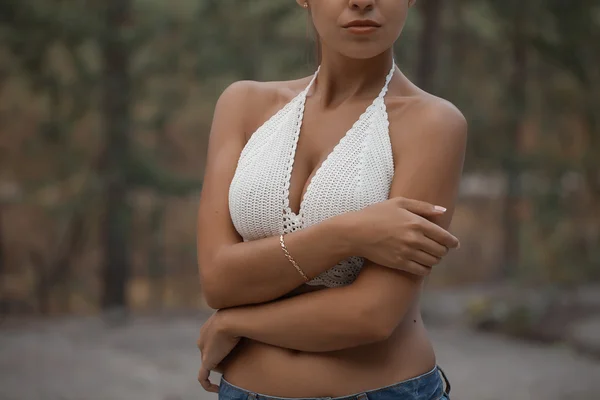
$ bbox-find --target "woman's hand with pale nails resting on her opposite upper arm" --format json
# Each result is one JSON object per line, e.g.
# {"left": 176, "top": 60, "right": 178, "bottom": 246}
{"left": 349, "top": 197, "right": 460, "bottom": 276}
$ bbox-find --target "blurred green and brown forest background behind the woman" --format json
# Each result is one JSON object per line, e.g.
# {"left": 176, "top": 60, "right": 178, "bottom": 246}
{"left": 0, "top": 0, "right": 600, "bottom": 322}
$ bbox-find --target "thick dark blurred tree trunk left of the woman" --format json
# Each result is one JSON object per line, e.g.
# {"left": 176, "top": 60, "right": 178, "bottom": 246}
{"left": 102, "top": 0, "right": 131, "bottom": 310}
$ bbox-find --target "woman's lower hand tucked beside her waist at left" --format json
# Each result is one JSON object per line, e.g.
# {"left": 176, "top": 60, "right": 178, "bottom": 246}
{"left": 197, "top": 310, "right": 240, "bottom": 393}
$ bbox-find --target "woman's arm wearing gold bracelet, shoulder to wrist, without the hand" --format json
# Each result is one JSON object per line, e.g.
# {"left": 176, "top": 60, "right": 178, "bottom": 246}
{"left": 198, "top": 81, "right": 378, "bottom": 309}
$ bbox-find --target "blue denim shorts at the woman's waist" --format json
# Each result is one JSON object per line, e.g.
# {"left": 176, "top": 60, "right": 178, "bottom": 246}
{"left": 219, "top": 366, "right": 450, "bottom": 400}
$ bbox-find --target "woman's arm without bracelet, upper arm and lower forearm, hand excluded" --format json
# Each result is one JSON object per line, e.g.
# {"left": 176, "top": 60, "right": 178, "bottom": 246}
{"left": 199, "top": 102, "right": 467, "bottom": 363}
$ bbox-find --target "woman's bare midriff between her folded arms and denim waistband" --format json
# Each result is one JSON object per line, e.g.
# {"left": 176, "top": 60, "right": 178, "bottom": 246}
{"left": 220, "top": 287, "right": 436, "bottom": 398}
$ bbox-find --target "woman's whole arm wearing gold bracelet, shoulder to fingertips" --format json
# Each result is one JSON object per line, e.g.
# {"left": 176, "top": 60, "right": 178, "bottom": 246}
{"left": 198, "top": 81, "right": 458, "bottom": 309}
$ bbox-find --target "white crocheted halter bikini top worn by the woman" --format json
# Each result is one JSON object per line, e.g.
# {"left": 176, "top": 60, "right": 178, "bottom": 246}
{"left": 229, "top": 64, "right": 396, "bottom": 287}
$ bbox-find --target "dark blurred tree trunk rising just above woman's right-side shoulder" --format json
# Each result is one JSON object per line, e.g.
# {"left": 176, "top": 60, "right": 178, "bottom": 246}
{"left": 417, "top": 0, "right": 443, "bottom": 91}
